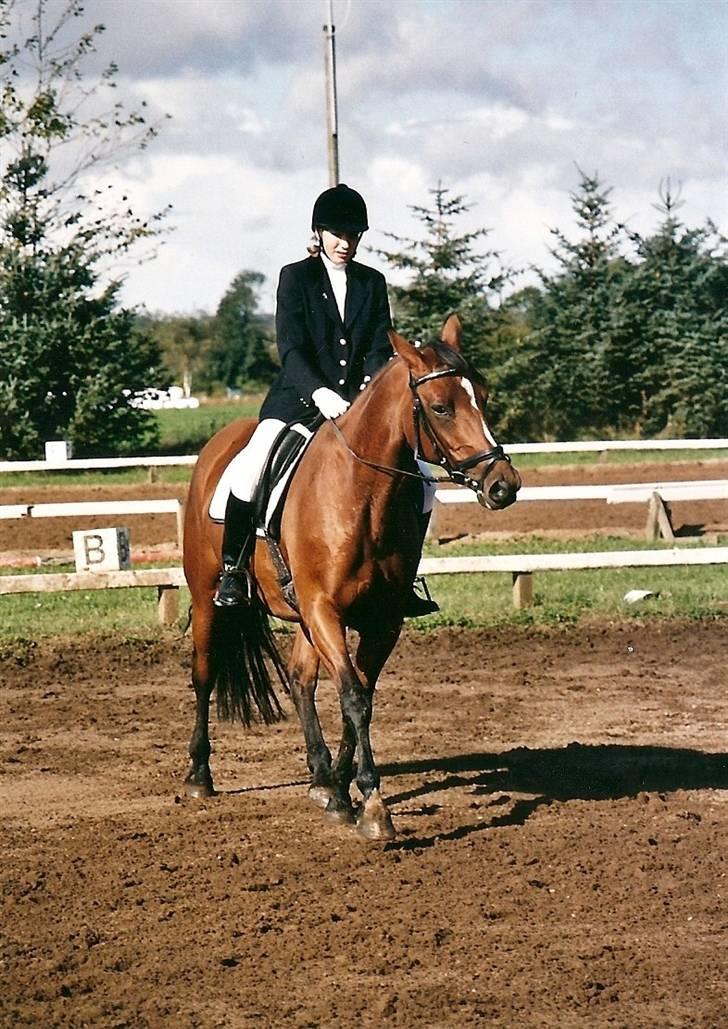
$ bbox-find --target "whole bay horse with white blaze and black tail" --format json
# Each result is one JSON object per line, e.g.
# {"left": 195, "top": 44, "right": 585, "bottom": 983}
{"left": 184, "top": 315, "right": 521, "bottom": 841}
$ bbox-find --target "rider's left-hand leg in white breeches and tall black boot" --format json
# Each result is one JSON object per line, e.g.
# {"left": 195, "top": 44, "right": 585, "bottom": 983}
{"left": 212, "top": 418, "right": 285, "bottom": 607}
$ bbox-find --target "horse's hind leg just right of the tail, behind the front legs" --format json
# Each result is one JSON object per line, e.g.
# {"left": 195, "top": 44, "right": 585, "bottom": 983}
{"left": 288, "top": 628, "right": 343, "bottom": 808}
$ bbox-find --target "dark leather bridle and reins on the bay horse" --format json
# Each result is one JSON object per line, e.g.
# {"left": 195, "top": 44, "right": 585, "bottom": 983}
{"left": 331, "top": 358, "right": 511, "bottom": 494}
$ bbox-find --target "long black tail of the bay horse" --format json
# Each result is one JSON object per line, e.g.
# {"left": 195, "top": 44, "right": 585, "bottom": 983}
{"left": 210, "top": 596, "right": 289, "bottom": 726}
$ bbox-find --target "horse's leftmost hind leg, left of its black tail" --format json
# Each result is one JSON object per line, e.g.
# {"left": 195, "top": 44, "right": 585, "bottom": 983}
{"left": 184, "top": 596, "right": 215, "bottom": 797}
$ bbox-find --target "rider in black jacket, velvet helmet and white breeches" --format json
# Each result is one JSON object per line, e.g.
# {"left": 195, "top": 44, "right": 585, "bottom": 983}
{"left": 213, "top": 183, "right": 438, "bottom": 616}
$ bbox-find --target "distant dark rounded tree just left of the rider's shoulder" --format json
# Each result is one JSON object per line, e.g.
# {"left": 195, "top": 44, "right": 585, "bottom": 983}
{"left": 209, "top": 272, "right": 278, "bottom": 388}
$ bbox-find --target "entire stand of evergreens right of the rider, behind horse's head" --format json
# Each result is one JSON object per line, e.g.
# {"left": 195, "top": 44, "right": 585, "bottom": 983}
{"left": 379, "top": 170, "right": 728, "bottom": 439}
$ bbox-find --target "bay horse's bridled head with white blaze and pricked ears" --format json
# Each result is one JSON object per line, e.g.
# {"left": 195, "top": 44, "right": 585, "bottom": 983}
{"left": 389, "top": 315, "right": 521, "bottom": 510}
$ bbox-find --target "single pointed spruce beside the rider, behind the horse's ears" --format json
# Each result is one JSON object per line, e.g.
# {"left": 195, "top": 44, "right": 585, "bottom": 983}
{"left": 376, "top": 183, "right": 513, "bottom": 370}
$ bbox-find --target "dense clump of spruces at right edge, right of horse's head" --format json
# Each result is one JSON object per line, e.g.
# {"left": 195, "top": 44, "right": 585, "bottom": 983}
{"left": 499, "top": 173, "right": 728, "bottom": 438}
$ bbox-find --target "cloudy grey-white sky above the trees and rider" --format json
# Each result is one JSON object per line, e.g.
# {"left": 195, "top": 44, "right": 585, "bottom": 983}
{"left": 12, "top": 0, "right": 728, "bottom": 312}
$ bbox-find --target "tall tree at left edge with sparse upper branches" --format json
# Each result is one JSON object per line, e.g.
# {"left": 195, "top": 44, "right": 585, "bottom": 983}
{"left": 0, "top": 0, "right": 165, "bottom": 458}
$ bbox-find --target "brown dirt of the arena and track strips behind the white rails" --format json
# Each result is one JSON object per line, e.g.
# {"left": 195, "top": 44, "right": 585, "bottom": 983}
{"left": 0, "top": 462, "right": 728, "bottom": 1029}
